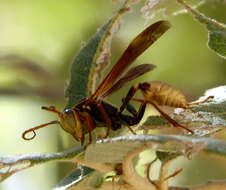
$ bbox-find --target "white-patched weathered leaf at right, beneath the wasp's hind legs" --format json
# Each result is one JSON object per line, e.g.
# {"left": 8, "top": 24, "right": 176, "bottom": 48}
{"left": 141, "top": 86, "right": 226, "bottom": 136}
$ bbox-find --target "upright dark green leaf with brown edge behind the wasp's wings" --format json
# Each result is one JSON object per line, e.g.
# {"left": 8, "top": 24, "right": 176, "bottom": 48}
{"left": 65, "top": 0, "right": 130, "bottom": 109}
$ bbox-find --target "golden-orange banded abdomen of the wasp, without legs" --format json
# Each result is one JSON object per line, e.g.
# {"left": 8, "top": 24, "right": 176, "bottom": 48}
{"left": 140, "top": 81, "right": 187, "bottom": 108}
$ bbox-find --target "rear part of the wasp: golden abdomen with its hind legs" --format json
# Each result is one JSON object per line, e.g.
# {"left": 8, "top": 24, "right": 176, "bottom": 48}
{"left": 121, "top": 81, "right": 214, "bottom": 133}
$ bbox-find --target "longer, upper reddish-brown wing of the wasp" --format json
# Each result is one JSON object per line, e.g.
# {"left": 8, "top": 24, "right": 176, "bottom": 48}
{"left": 90, "top": 21, "right": 170, "bottom": 100}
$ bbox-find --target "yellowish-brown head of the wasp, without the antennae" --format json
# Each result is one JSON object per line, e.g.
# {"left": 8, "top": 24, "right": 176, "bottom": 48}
{"left": 60, "top": 109, "right": 82, "bottom": 141}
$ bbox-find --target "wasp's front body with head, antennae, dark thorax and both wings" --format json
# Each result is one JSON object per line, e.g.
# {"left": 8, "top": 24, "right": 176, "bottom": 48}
{"left": 22, "top": 20, "right": 170, "bottom": 144}
